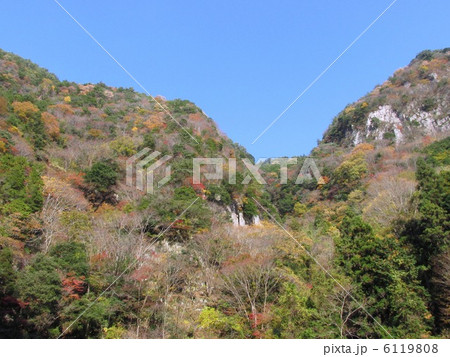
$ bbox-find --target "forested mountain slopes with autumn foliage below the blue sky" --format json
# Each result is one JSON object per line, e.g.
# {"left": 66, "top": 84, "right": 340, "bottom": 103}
{"left": 0, "top": 49, "right": 450, "bottom": 338}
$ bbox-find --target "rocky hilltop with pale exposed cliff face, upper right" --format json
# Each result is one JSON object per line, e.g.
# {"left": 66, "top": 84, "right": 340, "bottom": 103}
{"left": 323, "top": 49, "right": 450, "bottom": 145}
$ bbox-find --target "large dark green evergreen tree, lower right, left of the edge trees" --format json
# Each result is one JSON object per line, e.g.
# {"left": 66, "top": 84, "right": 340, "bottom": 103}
{"left": 336, "top": 214, "right": 429, "bottom": 337}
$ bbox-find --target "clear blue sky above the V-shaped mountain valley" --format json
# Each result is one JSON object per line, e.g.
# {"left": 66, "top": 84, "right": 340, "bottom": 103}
{"left": 0, "top": 0, "right": 450, "bottom": 158}
